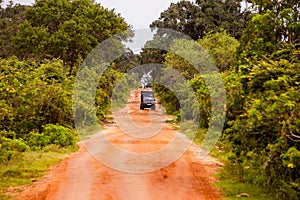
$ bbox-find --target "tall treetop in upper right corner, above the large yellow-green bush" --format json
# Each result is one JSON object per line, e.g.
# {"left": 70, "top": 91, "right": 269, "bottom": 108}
{"left": 238, "top": 1, "right": 300, "bottom": 64}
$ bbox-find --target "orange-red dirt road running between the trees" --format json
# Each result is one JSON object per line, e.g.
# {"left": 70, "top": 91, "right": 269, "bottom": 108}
{"left": 17, "top": 91, "right": 221, "bottom": 200}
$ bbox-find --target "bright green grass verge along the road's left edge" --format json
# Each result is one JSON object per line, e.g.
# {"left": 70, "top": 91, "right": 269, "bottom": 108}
{"left": 0, "top": 145, "right": 78, "bottom": 199}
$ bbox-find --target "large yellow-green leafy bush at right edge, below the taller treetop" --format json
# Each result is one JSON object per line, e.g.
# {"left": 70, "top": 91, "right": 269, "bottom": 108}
{"left": 226, "top": 48, "right": 300, "bottom": 199}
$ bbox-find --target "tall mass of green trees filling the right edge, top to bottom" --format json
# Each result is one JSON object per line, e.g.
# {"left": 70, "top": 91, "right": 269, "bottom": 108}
{"left": 225, "top": 1, "right": 300, "bottom": 199}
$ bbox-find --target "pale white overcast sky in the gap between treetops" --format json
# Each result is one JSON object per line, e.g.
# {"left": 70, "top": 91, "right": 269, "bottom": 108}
{"left": 4, "top": 0, "right": 195, "bottom": 29}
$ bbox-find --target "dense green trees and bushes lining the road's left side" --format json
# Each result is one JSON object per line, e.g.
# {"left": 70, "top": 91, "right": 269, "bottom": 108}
{"left": 0, "top": 0, "right": 128, "bottom": 166}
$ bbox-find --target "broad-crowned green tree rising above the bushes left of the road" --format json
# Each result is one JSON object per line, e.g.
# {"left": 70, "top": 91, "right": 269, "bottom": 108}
{"left": 13, "top": 0, "right": 128, "bottom": 73}
